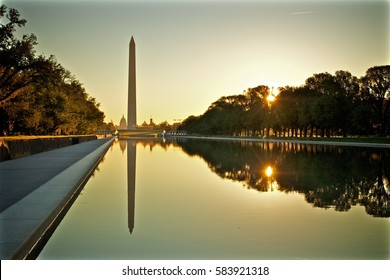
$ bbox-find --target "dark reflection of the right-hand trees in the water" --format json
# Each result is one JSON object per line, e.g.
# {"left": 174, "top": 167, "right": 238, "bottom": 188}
{"left": 174, "top": 140, "right": 390, "bottom": 217}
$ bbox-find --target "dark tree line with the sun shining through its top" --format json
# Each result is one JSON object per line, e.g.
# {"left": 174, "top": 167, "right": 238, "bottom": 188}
{"left": 178, "top": 65, "right": 390, "bottom": 137}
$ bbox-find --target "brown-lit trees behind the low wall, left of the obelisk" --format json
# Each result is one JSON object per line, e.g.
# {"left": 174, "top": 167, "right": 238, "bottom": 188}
{"left": 0, "top": 5, "right": 104, "bottom": 135}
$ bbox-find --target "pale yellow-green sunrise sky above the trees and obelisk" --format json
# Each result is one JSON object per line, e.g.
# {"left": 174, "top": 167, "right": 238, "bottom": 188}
{"left": 1, "top": 0, "right": 390, "bottom": 124}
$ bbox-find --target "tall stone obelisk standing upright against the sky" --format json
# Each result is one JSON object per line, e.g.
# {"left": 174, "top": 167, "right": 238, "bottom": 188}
{"left": 127, "top": 36, "right": 137, "bottom": 129}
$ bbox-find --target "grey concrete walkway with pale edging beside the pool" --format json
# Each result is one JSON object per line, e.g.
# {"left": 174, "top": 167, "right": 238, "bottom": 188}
{"left": 0, "top": 138, "right": 114, "bottom": 260}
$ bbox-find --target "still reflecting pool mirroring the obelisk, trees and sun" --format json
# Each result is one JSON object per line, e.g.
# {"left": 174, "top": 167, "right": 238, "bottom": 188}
{"left": 38, "top": 138, "right": 390, "bottom": 260}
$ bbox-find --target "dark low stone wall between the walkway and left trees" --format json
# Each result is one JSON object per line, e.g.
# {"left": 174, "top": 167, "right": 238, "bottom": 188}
{"left": 0, "top": 135, "right": 97, "bottom": 161}
